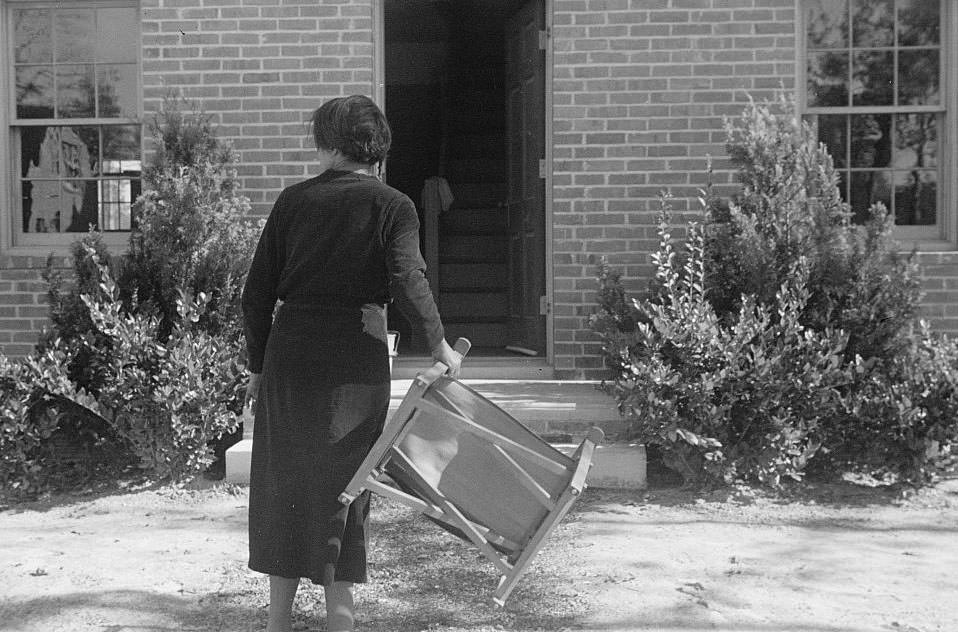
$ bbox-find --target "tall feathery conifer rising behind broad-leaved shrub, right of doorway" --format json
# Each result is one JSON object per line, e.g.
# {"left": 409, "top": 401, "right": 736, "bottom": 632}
{"left": 704, "top": 96, "right": 921, "bottom": 360}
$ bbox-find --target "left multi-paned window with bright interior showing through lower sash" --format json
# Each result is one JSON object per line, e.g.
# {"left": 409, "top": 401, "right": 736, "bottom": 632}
{"left": 7, "top": 2, "right": 141, "bottom": 245}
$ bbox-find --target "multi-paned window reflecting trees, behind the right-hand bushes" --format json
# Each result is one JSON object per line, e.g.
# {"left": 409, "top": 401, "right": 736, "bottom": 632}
{"left": 802, "top": 0, "right": 949, "bottom": 239}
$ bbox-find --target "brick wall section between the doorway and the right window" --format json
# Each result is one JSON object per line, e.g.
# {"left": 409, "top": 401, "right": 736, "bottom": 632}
{"left": 553, "top": 0, "right": 795, "bottom": 377}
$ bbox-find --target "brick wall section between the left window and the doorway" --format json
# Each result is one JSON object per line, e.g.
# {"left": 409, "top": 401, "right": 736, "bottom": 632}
{"left": 141, "top": 0, "right": 373, "bottom": 214}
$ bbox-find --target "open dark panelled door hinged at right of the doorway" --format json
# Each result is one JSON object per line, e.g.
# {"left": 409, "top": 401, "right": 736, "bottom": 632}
{"left": 506, "top": 0, "right": 546, "bottom": 354}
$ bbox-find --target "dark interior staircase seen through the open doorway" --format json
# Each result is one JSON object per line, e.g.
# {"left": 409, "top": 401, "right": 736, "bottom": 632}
{"left": 438, "top": 26, "right": 509, "bottom": 354}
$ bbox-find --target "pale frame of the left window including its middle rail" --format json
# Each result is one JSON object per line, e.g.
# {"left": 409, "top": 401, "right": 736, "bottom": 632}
{"left": 0, "top": 0, "right": 145, "bottom": 256}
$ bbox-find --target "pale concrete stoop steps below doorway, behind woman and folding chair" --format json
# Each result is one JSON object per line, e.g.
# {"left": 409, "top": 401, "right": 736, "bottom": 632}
{"left": 226, "top": 379, "right": 646, "bottom": 489}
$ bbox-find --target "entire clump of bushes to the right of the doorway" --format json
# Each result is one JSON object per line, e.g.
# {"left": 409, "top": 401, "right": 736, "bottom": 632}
{"left": 591, "top": 98, "right": 958, "bottom": 484}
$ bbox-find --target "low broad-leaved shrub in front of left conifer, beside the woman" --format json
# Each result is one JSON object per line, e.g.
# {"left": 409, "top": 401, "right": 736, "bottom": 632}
{"left": 83, "top": 250, "right": 245, "bottom": 479}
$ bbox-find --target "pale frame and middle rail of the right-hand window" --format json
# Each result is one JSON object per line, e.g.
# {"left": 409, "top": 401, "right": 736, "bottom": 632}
{"left": 795, "top": 0, "right": 958, "bottom": 252}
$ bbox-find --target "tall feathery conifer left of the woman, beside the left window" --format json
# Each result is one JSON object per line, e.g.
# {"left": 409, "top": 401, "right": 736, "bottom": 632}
{"left": 119, "top": 94, "right": 262, "bottom": 335}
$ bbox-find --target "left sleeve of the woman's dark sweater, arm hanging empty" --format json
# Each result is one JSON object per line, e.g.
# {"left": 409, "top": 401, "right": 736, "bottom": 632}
{"left": 243, "top": 193, "right": 286, "bottom": 373}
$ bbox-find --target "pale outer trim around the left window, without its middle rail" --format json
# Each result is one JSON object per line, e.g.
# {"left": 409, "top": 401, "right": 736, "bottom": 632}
{"left": 0, "top": 0, "right": 145, "bottom": 257}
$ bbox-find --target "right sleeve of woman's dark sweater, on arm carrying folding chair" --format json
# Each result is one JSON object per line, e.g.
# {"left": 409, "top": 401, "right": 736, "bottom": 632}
{"left": 383, "top": 196, "right": 445, "bottom": 349}
